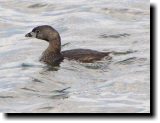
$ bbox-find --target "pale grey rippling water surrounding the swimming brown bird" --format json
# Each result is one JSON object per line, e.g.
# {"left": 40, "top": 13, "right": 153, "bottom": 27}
{"left": 0, "top": 0, "right": 150, "bottom": 113}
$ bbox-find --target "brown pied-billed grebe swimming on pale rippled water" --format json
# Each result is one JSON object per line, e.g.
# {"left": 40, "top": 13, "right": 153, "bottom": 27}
{"left": 25, "top": 25, "right": 110, "bottom": 64}
